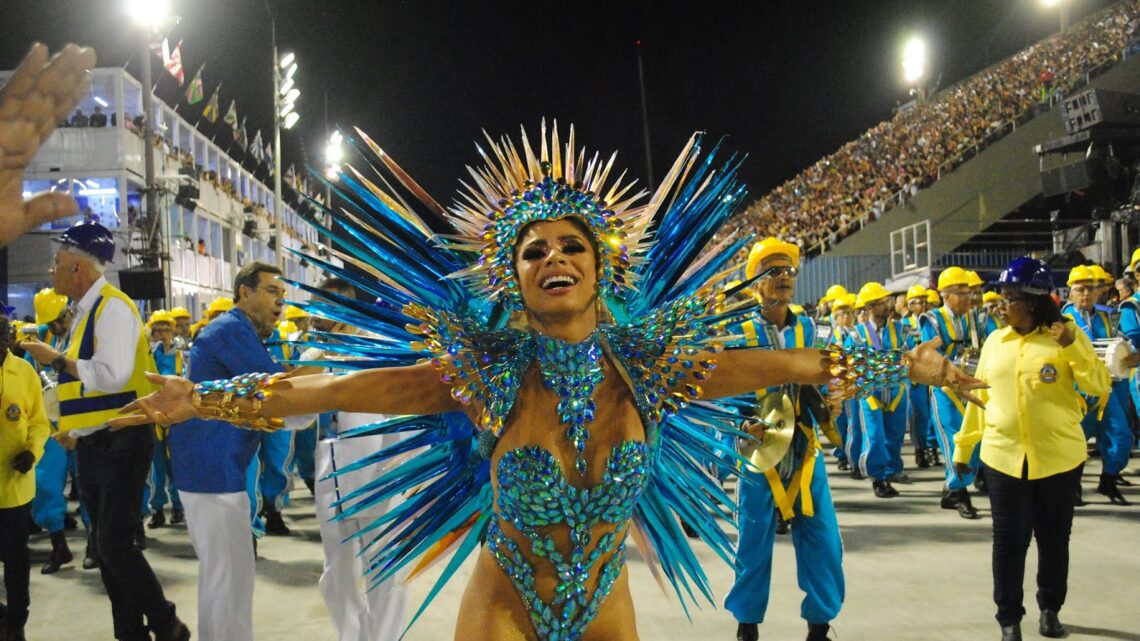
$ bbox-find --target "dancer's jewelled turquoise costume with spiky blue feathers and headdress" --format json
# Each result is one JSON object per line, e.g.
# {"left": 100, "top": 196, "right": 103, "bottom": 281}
{"left": 189, "top": 123, "right": 898, "bottom": 641}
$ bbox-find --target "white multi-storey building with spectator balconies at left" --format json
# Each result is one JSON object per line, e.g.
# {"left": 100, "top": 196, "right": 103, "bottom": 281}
{"left": 0, "top": 67, "right": 330, "bottom": 318}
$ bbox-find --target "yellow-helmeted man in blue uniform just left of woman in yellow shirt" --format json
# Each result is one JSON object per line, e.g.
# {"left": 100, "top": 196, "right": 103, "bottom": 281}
{"left": 921, "top": 266, "right": 984, "bottom": 519}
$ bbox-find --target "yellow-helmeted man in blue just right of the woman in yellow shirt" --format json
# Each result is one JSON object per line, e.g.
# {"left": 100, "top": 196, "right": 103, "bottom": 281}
{"left": 1062, "top": 265, "right": 1140, "bottom": 505}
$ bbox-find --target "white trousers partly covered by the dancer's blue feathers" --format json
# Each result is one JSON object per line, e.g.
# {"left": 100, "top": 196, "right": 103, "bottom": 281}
{"left": 316, "top": 412, "right": 407, "bottom": 641}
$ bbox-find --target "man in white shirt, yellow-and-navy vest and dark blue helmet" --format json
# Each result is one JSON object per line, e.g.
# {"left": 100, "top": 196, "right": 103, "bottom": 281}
{"left": 21, "top": 221, "right": 190, "bottom": 641}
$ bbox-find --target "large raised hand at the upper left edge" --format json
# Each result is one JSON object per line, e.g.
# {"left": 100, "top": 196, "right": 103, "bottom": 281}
{"left": 0, "top": 43, "right": 95, "bottom": 246}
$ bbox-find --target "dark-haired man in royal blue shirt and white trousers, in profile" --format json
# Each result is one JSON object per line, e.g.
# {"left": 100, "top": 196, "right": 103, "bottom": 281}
{"left": 170, "top": 262, "right": 311, "bottom": 641}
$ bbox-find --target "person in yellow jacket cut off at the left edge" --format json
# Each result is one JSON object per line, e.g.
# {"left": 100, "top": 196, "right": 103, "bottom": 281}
{"left": 0, "top": 308, "right": 51, "bottom": 639}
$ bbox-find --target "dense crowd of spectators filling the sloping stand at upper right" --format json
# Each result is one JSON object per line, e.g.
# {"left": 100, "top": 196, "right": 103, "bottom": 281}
{"left": 722, "top": 0, "right": 1140, "bottom": 254}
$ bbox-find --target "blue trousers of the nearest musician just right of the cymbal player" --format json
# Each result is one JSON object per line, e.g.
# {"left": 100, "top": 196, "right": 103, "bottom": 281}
{"left": 858, "top": 387, "right": 911, "bottom": 480}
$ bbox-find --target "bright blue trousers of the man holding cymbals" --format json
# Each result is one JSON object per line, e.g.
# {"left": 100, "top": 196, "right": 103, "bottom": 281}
{"left": 724, "top": 453, "right": 846, "bottom": 624}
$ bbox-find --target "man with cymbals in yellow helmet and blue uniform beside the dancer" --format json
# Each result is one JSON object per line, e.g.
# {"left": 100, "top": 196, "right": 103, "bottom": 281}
{"left": 724, "top": 237, "right": 845, "bottom": 641}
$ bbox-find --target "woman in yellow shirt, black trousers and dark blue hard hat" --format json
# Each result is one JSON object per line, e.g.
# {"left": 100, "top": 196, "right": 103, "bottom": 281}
{"left": 954, "top": 258, "right": 1110, "bottom": 641}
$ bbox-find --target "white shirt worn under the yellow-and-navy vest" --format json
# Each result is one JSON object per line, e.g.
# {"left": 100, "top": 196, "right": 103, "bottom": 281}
{"left": 68, "top": 276, "right": 143, "bottom": 436}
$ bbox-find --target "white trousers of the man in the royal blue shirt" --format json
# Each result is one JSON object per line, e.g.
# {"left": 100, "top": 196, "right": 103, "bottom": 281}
{"left": 178, "top": 490, "right": 254, "bottom": 641}
